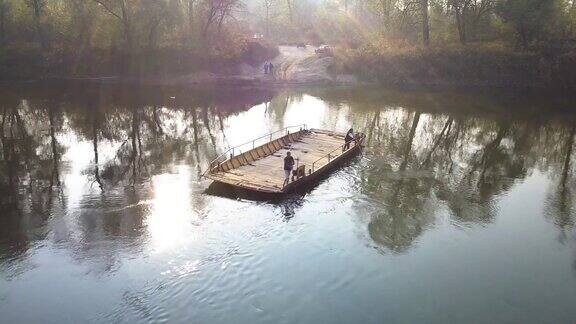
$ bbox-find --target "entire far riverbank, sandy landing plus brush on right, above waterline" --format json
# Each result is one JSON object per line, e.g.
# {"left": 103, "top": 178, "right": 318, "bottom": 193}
{"left": 0, "top": 45, "right": 576, "bottom": 90}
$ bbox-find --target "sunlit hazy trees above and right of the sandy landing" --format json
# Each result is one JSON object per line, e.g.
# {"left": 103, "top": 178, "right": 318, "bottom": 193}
{"left": 241, "top": 0, "right": 576, "bottom": 50}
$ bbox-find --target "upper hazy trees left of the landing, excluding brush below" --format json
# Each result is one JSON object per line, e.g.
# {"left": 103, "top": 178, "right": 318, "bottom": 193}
{"left": 0, "top": 0, "right": 248, "bottom": 50}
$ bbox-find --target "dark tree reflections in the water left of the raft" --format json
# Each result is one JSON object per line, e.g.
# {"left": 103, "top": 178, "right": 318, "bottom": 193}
{"left": 0, "top": 85, "right": 270, "bottom": 272}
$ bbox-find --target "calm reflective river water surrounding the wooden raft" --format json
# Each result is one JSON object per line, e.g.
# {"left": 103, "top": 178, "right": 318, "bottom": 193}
{"left": 0, "top": 86, "right": 576, "bottom": 323}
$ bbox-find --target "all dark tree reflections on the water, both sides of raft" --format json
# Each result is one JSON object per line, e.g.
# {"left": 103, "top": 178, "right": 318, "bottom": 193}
{"left": 0, "top": 85, "right": 576, "bottom": 271}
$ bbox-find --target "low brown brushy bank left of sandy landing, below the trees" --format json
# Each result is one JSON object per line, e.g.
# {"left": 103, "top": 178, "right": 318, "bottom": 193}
{"left": 0, "top": 40, "right": 279, "bottom": 83}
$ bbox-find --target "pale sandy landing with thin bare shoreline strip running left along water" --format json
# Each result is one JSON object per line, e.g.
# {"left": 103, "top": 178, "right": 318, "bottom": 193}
{"left": 0, "top": 46, "right": 360, "bottom": 90}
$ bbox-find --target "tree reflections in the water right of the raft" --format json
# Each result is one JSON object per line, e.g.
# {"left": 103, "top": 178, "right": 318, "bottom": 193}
{"left": 318, "top": 87, "right": 574, "bottom": 253}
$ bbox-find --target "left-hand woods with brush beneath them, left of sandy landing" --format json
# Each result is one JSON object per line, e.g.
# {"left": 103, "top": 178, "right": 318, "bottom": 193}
{"left": 0, "top": 0, "right": 249, "bottom": 74}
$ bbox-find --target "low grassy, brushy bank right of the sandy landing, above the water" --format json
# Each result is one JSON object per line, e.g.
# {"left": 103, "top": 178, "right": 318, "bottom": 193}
{"left": 335, "top": 45, "right": 576, "bottom": 88}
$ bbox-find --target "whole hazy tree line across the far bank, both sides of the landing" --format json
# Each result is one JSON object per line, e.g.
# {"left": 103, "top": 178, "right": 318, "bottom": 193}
{"left": 0, "top": 0, "right": 576, "bottom": 78}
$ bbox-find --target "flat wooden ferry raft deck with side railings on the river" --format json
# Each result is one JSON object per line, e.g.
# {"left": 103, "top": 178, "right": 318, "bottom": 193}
{"left": 204, "top": 125, "right": 364, "bottom": 194}
